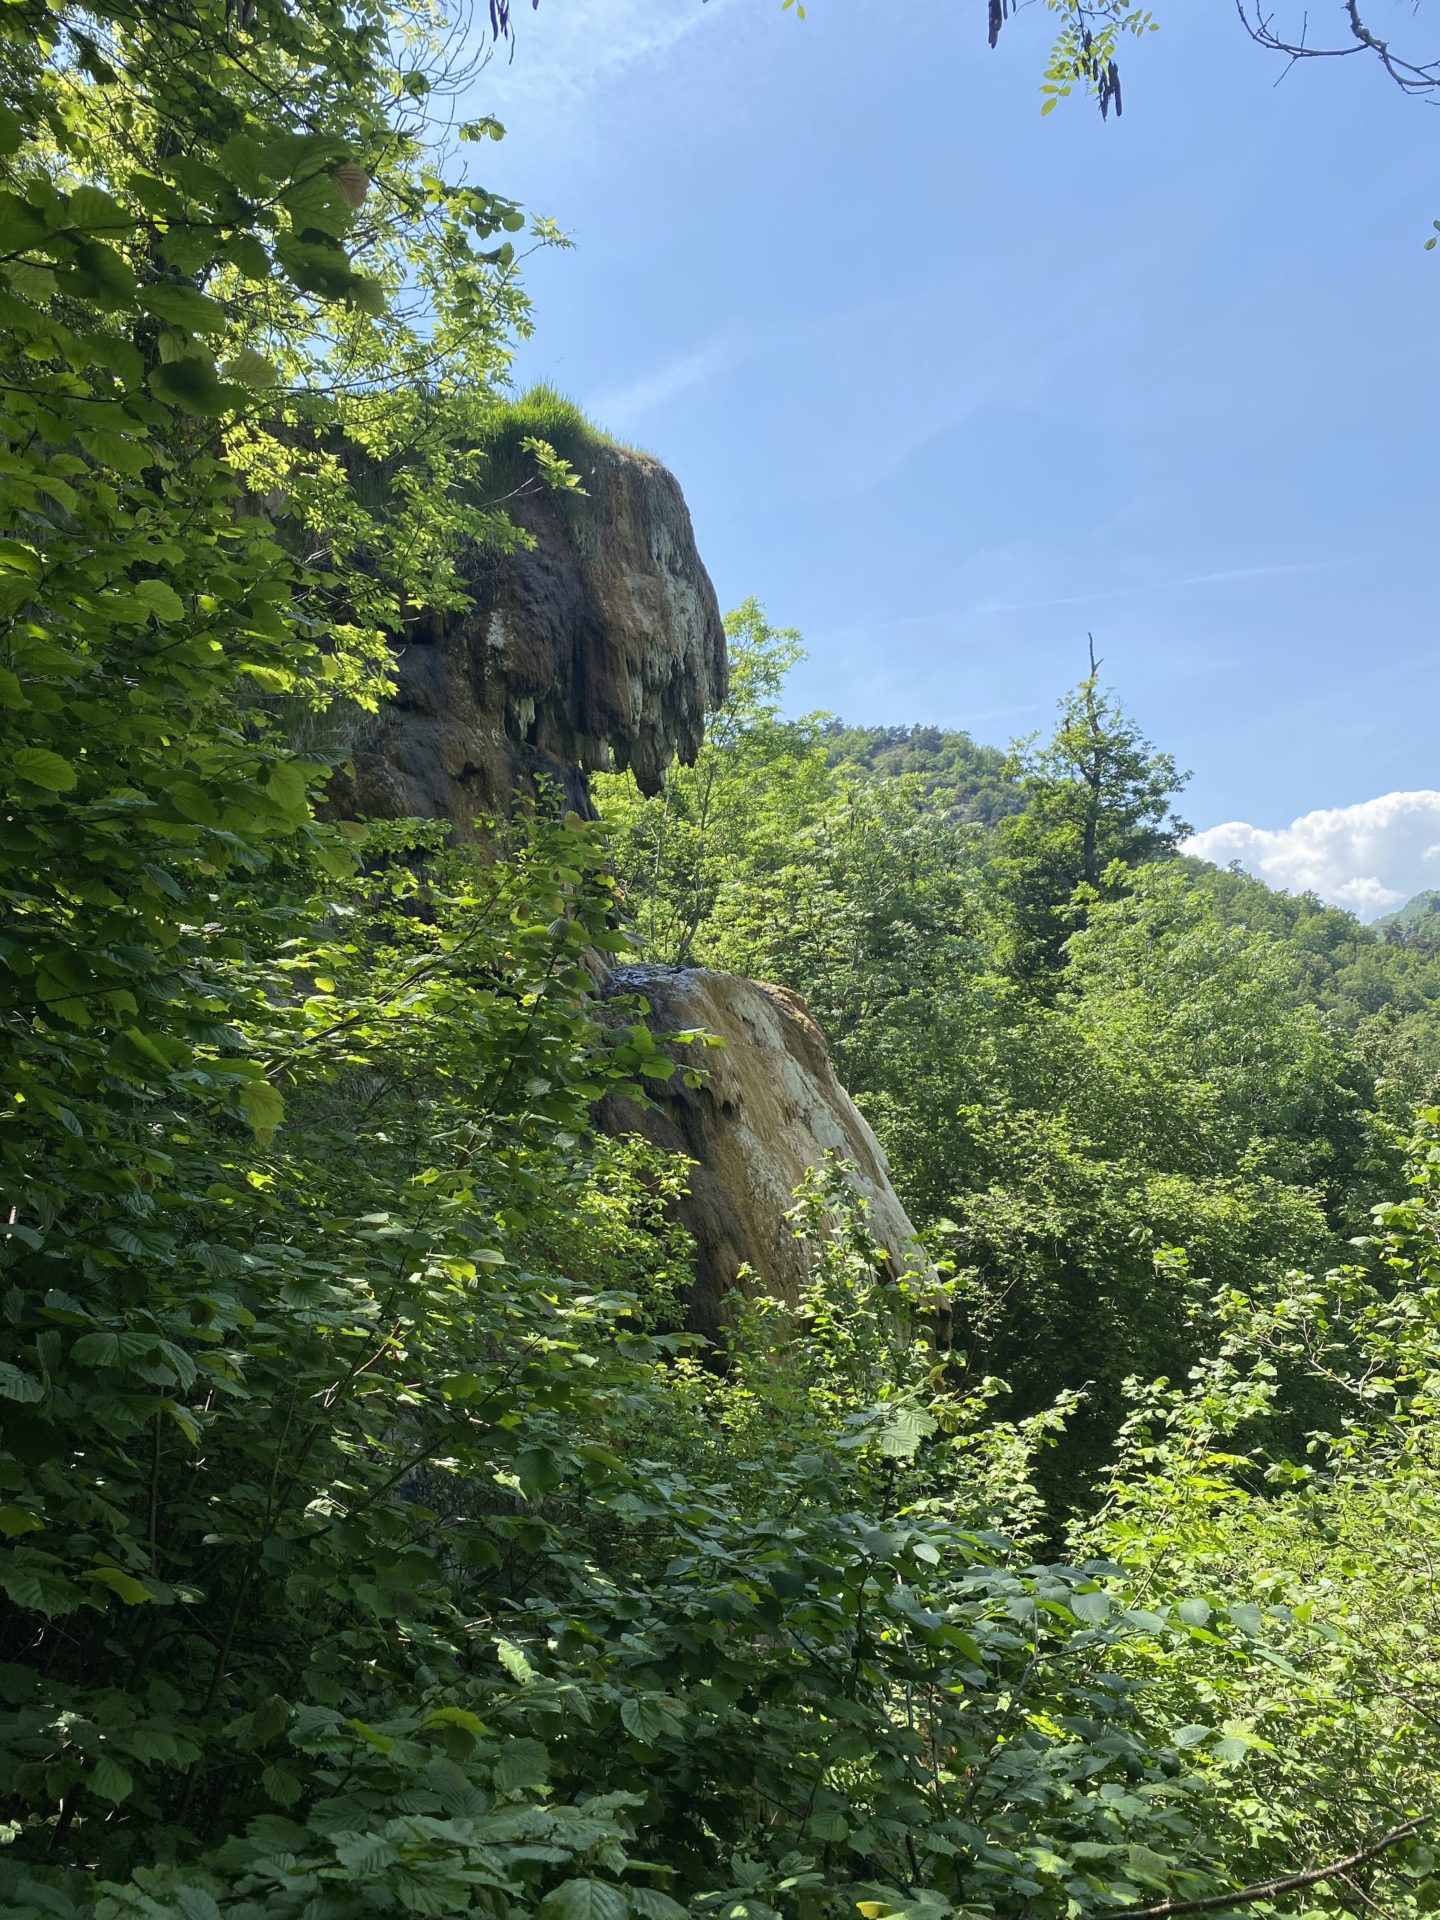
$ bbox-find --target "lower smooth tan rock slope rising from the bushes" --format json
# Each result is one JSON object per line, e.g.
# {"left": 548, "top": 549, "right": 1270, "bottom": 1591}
{"left": 601, "top": 966, "right": 925, "bottom": 1332}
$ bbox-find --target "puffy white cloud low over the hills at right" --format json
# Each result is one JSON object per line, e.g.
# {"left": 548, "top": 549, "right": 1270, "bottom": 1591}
{"left": 1185, "top": 787, "right": 1440, "bottom": 920}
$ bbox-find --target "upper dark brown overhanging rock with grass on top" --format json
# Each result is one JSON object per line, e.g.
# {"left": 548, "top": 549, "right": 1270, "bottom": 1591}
{"left": 332, "top": 442, "right": 726, "bottom": 835}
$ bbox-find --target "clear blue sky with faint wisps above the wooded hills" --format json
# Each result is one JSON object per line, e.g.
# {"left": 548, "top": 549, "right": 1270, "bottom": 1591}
{"left": 467, "top": 0, "right": 1440, "bottom": 912}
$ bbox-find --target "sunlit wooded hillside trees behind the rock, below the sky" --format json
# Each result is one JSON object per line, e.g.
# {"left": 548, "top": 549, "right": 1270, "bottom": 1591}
{"left": 601, "top": 603, "right": 1440, "bottom": 1503}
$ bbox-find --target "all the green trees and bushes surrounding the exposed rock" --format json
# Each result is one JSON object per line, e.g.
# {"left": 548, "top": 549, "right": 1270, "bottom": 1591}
{"left": 0, "top": 0, "right": 1440, "bottom": 1920}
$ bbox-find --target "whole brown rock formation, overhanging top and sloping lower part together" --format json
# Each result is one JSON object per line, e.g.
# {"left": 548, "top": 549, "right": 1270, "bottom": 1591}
{"left": 330, "top": 444, "right": 914, "bottom": 1332}
